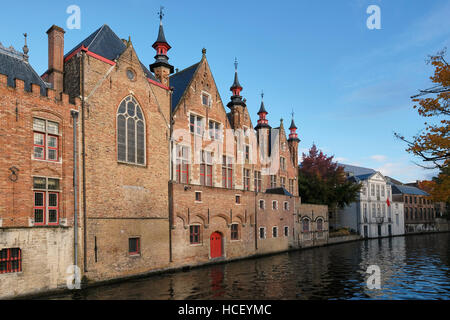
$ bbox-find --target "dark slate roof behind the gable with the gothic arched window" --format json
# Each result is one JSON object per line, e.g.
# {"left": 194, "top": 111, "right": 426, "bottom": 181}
{"left": 64, "top": 24, "right": 158, "bottom": 81}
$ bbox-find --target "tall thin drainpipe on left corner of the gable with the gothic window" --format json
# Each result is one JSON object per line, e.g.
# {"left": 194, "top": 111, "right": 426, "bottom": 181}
{"left": 80, "top": 51, "right": 88, "bottom": 272}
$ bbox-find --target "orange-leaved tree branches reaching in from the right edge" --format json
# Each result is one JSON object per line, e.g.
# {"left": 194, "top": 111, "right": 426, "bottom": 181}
{"left": 395, "top": 49, "right": 450, "bottom": 169}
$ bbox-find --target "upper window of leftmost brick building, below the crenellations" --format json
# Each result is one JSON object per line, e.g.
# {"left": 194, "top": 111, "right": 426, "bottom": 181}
{"left": 33, "top": 118, "right": 60, "bottom": 161}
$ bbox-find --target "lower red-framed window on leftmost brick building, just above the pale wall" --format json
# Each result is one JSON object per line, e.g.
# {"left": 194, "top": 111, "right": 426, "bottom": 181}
{"left": 33, "top": 177, "right": 61, "bottom": 225}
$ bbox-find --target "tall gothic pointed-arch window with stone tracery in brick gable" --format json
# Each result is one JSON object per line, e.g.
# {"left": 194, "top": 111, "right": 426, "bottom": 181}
{"left": 117, "top": 96, "right": 145, "bottom": 165}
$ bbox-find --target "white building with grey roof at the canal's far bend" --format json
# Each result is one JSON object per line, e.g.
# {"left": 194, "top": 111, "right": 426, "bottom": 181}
{"left": 334, "top": 165, "right": 405, "bottom": 238}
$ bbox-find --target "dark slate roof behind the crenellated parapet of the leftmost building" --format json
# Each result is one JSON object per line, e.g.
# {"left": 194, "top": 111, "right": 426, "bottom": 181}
{"left": 0, "top": 43, "right": 51, "bottom": 95}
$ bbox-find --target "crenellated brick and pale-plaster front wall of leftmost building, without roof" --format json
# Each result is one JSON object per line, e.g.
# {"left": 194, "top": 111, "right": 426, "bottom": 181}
{"left": 0, "top": 70, "right": 79, "bottom": 297}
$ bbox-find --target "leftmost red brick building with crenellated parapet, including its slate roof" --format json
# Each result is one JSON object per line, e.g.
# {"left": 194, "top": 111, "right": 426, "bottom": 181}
{"left": 0, "top": 27, "right": 80, "bottom": 297}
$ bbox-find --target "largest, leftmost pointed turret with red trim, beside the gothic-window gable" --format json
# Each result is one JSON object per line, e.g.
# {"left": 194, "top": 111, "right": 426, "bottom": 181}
{"left": 150, "top": 7, "right": 174, "bottom": 86}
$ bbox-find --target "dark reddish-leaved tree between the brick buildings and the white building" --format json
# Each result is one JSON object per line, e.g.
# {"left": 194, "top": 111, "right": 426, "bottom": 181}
{"left": 298, "top": 145, "right": 361, "bottom": 211}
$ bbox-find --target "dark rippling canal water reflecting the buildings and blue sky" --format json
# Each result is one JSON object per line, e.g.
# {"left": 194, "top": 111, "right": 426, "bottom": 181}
{"left": 51, "top": 233, "right": 450, "bottom": 300}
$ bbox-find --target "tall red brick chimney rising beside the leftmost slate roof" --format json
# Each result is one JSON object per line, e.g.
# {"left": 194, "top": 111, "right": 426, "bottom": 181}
{"left": 47, "top": 25, "right": 66, "bottom": 99}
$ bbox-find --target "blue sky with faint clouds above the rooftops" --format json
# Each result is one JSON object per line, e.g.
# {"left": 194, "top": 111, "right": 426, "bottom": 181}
{"left": 0, "top": 0, "right": 450, "bottom": 182}
